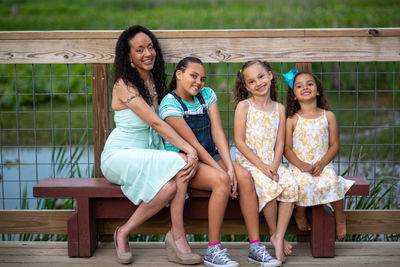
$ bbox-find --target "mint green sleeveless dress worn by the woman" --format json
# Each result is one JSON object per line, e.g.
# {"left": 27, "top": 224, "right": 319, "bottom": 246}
{"left": 101, "top": 109, "right": 186, "bottom": 205}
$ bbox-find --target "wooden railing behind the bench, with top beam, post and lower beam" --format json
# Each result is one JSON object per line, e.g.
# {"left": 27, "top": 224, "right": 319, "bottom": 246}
{"left": 0, "top": 28, "right": 400, "bottom": 239}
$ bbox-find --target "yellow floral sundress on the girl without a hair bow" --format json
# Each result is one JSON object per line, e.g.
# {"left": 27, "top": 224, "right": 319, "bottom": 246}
{"left": 235, "top": 100, "right": 299, "bottom": 211}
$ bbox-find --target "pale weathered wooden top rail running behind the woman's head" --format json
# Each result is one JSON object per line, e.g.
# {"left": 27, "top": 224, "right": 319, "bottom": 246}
{"left": 0, "top": 28, "right": 400, "bottom": 64}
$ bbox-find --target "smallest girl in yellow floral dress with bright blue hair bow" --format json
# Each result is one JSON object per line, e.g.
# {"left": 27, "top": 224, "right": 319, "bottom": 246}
{"left": 283, "top": 69, "right": 354, "bottom": 240}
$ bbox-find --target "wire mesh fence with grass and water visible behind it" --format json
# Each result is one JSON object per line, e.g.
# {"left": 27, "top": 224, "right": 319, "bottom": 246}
{"left": 0, "top": 62, "right": 400, "bottom": 209}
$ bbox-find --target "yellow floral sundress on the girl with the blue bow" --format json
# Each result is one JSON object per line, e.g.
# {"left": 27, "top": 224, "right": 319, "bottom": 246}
{"left": 288, "top": 111, "right": 354, "bottom": 206}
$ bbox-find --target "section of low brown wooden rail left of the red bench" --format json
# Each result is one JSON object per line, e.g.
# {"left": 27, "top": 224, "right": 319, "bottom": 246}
{"left": 0, "top": 210, "right": 74, "bottom": 234}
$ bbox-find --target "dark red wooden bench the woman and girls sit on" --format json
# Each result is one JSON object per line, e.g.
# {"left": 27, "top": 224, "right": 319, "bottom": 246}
{"left": 33, "top": 176, "right": 369, "bottom": 257}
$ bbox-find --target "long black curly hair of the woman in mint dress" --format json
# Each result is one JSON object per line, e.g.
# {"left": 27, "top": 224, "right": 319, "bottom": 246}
{"left": 114, "top": 25, "right": 167, "bottom": 106}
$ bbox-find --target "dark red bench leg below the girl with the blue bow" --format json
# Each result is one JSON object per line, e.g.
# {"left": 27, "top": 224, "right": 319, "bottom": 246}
{"left": 311, "top": 205, "right": 335, "bottom": 258}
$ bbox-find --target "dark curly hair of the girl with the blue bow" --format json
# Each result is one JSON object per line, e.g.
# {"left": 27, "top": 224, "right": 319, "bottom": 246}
{"left": 286, "top": 72, "right": 330, "bottom": 118}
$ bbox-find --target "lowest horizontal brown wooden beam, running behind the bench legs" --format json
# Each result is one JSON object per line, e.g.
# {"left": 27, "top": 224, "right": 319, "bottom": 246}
{"left": 0, "top": 210, "right": 400, "bottom": 235}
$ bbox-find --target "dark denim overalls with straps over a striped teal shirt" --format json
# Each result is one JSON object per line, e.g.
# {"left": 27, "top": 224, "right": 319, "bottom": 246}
{"left": 171, "top": 92, "right": 221, "bottom": 161}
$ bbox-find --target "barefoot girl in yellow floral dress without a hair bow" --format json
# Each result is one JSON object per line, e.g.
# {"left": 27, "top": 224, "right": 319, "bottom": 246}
{"left": 234, "top": 60, "right": 298, "bottom": 262}
